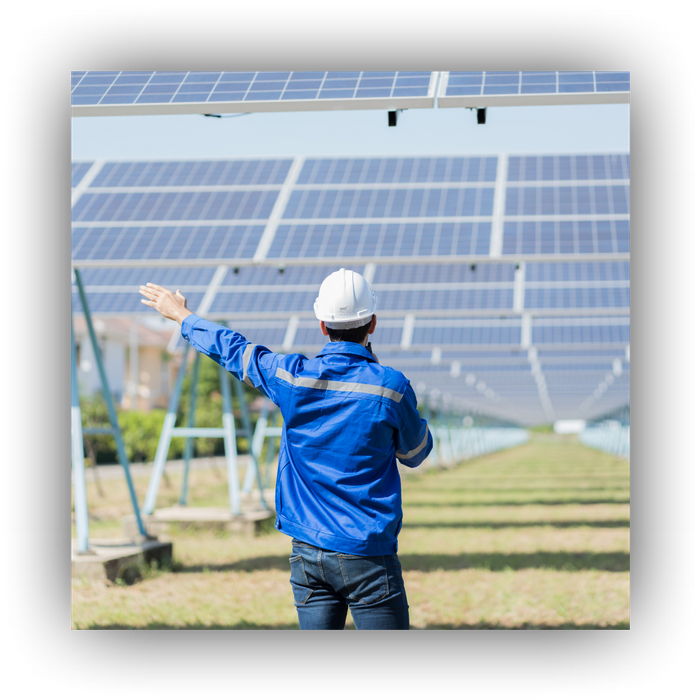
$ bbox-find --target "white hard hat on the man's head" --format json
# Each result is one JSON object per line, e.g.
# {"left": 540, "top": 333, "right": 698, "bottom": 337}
{"left": 314, "top": 268, "right": 377, "bottom": 330}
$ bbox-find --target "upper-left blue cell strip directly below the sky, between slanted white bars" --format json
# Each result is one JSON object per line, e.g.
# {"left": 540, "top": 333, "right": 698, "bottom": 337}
{"left": 91, "top": 159, "right": 292, "bottom": 187}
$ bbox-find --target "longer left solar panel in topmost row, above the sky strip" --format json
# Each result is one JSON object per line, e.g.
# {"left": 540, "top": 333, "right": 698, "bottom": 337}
{"left": 71, "top": 71, "right": 437, "bottom": 116}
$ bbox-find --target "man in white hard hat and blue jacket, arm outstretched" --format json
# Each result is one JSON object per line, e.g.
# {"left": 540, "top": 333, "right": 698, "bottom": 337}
{"left": 140, "top": 269, "right": 433, "bottom": 629}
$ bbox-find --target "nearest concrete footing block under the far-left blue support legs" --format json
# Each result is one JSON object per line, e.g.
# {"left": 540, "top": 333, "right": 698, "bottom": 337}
{"left": 70, "top": 538, "right": 173, "bottom": 582}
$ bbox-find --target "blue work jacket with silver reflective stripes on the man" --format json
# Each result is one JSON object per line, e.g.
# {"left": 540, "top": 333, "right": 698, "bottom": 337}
{"left": 182, "top": 314, "right": 433, "bottom": 556}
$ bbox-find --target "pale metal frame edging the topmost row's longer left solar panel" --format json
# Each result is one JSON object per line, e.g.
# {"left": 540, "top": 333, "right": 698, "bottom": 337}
{"left": 71, "top": 71, "right": 439, "bottom": 117}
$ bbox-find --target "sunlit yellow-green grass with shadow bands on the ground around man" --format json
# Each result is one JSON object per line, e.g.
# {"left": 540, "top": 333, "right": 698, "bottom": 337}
{"left": 71, "top": 433, "right": 630, "bottom": 630}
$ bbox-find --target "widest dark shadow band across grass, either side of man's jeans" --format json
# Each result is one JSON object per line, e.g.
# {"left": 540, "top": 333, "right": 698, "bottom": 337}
{"left": 173, "top": 552, "right": 630, "bottom": 573}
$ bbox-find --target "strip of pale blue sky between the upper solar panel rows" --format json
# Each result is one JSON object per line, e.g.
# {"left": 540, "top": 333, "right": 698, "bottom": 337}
{"left": 71, "top": 104, "right": 630, "bottom": 160}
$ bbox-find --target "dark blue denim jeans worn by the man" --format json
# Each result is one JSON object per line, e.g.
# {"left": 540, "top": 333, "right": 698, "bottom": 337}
{"left": 289, "top": 540, "right": 408, "bottom": 630}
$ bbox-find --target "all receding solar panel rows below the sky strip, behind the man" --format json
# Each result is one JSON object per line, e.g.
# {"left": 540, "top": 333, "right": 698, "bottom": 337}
{"left": 71, "top": 154, "right": 630, "bottom": 423}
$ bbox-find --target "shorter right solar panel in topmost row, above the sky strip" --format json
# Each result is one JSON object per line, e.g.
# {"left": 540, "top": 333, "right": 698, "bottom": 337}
{"left": 438, "top": 71, "right": 630, "bottom": 107}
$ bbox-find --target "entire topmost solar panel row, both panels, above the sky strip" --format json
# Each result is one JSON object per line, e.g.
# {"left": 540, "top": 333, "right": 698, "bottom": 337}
{"left": 71, "top": 71, "right": 630, "bottom": 116}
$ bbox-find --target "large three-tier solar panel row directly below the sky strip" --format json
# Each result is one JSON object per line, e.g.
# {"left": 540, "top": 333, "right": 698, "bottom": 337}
{"left": 71, "top": 154, "right": 630, "bottom": 266}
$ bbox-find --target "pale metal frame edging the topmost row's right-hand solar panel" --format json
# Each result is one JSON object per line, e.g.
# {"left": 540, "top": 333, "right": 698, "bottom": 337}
{"left": 437, "top": 71, "right": 630, "bottom": 108}
